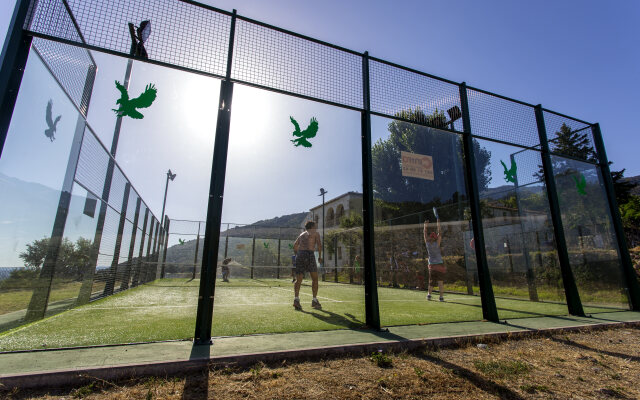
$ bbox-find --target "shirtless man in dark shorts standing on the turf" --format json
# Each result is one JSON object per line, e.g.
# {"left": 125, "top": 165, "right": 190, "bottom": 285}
{"left": 293, "top": 221, "right": 322, "bottom": 310}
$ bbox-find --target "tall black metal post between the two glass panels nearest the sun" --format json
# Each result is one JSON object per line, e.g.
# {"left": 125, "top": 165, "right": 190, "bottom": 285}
{"left": 194, "top": 10, "right": 236, "bottom": 344}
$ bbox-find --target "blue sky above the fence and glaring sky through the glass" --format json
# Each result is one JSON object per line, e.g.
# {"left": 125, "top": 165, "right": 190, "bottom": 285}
{"left": 0, "top": 0, "right": 640, "bottom": 266}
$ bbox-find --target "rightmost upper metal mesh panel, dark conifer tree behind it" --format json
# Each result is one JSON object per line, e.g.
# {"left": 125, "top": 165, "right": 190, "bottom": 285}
{"left": 543, "top": 110, "right": 597, "bottom": 163}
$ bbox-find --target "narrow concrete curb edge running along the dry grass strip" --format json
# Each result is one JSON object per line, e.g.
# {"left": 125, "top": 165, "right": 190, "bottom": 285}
{"left": 0, "top": 321, "right": 640, "bottom": 390}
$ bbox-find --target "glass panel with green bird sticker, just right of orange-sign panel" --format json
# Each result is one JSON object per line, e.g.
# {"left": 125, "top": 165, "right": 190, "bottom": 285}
{"left": 468, "top": 139, "right": 568, "bottom": 318}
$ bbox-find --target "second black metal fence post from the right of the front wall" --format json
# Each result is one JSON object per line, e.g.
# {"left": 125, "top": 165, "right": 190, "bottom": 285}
{"left": 535, "top": 104, "right": 584, "bottom": 316}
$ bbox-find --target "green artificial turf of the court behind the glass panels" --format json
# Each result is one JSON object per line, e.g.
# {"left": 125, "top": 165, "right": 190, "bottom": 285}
{"left": 0, "top": 279, "right": 624, "bottom": 351}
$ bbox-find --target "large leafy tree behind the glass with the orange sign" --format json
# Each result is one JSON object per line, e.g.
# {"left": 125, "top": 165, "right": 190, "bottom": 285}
{"left": 371, "top": 108, "right": 491, "bottom": 218}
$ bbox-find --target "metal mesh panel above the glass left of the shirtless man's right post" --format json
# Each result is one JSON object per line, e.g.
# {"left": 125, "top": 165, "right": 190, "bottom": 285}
{"left": 231, "top": 19, "right": 362, "bottom": 108}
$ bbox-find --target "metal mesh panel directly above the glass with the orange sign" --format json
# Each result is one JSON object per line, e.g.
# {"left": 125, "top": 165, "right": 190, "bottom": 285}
{"left": 369, "top": 60, "right": 462, "bottom": 130}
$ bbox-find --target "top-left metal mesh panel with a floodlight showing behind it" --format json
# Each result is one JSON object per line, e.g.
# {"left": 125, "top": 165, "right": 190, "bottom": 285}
{"left": 28, "top": 0, "right": 231, "bottom": 76}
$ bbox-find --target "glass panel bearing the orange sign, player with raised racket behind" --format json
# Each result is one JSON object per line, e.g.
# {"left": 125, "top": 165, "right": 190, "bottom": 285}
{"left": 370, "top": 114, "right": 482, "bottom": 325}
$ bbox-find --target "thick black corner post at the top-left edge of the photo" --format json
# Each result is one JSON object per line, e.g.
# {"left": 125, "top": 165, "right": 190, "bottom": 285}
{"left": 0, "top": 0, "right": 32, "bottom": 156}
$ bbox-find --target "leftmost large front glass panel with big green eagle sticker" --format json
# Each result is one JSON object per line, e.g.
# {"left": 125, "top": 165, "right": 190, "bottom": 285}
{"left": 0, "top": 47, "right": 219, "bottom": 350}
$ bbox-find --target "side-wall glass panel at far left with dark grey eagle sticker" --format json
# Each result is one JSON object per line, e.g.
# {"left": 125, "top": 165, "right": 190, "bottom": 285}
{"left": 0, "top": 51, "right": 80, "bottom": 334}
